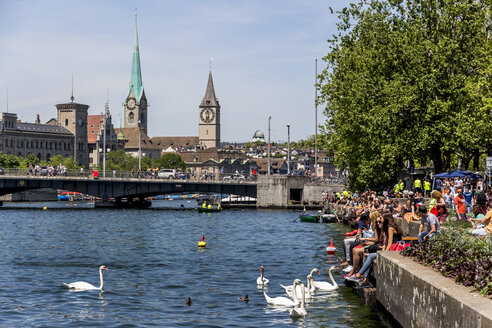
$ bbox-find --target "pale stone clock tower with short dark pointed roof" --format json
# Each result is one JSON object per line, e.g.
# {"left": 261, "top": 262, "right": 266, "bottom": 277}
{"left": 198, "top": 71, "right": 220, "bottom": 149}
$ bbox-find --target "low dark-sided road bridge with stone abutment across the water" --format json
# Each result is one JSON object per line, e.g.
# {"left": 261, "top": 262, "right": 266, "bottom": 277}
{"left": 0, "top": 173, "right": 343, "bottom": 208}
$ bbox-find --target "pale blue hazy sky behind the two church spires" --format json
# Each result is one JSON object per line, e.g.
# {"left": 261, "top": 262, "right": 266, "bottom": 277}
{"left": 0, "top": 0, "right": 349, "bottom": 142}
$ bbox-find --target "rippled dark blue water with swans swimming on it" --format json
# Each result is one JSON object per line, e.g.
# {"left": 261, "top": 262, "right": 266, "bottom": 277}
{"left": 0, "top": 201, "right": 384, "bottom": 328}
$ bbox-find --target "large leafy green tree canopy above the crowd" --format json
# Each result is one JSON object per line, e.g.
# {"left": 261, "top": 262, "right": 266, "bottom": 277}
{"left": 319, "top": 0, "right": 492, "bottom": 189}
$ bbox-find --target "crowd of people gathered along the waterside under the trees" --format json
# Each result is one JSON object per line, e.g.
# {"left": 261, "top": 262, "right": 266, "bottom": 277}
{"left": 324, "top": 179, "right": 492, "bottom": 288}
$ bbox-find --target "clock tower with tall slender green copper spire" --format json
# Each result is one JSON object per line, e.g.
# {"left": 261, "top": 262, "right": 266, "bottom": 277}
{"left": 124, "top": 14, "right": 148, "bottom": 134}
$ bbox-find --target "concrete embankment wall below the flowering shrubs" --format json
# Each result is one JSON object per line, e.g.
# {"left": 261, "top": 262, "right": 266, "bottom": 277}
{"left": 374, "top": 252, "right": 492, "bottom": 328}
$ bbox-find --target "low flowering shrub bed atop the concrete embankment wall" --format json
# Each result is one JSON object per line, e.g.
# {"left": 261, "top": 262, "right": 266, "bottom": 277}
{"left": 401, "top": 231, "right": 492, "bottom": 298}
